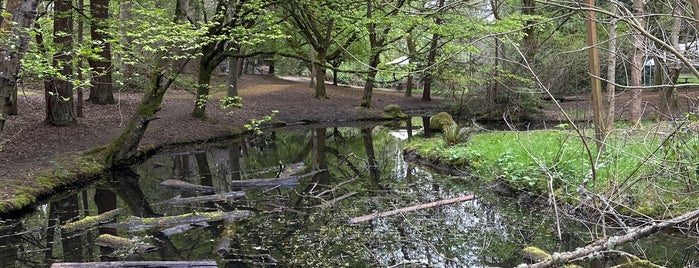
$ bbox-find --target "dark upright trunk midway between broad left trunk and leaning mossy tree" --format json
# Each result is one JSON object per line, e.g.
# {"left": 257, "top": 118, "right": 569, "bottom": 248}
{"left": 89, "top": 0, "right": 114, "bottom": 104}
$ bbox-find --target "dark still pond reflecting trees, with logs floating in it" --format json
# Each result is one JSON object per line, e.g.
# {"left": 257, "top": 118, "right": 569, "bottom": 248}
{"left": 0, "top": 122, "right": 699, "bottom": 267}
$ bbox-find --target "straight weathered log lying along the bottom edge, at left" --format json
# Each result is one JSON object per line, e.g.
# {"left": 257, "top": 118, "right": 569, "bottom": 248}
{"left": 51, "top": 261, "right": 218, "bottom": 268}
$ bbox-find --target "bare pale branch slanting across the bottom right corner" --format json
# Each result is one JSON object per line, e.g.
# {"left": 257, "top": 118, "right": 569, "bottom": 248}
{"left": 517, "top": 209, "right": 699, "bottom": 268}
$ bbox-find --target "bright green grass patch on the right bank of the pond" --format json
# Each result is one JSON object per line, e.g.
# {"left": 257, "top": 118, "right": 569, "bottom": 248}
{"left": 406, "top": 122, "right": 699, "bottom": 215}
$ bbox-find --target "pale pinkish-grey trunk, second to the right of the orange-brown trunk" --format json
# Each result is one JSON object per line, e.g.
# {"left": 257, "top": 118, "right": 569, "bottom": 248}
{"left": 629, "top": 0, "right": 645, "bottom": 127}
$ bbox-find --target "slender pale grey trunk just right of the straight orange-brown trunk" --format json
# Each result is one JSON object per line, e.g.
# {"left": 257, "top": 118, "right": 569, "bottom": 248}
{"left": 605, "top": 5, "right": 617, "bottom": 131}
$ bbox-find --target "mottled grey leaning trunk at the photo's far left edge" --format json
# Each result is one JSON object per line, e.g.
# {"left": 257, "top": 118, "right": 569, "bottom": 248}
{"left": 0, "top": 0, "right": 39, "bottom": 137}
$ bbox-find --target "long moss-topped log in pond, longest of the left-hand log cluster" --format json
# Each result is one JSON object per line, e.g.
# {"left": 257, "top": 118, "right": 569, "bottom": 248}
{"left": 105, "top": 211, "right": 250, "bottom": 231}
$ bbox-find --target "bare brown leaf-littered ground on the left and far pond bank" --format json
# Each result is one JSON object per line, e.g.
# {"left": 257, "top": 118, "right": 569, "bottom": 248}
{"left": 0, "top": 75, "right": 439, "bottom": 206}
